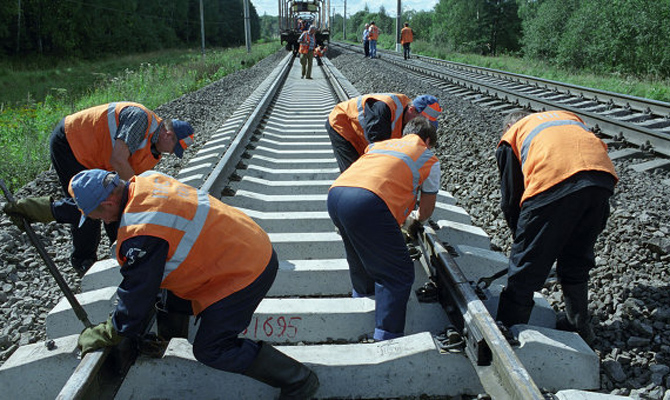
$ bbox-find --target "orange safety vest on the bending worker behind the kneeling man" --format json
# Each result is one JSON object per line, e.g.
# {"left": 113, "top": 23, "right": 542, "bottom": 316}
{"left": 65, "top": 101, "right": 161, "bottom": 174}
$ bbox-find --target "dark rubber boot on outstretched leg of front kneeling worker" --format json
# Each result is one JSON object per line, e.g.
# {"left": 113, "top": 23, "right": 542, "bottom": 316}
{"left": 244, "top": 342, "right": 319, "bottom": 400}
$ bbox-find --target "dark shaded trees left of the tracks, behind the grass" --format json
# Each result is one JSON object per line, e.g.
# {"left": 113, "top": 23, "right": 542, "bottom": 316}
{"left": 0, "top": 0, "right": 260, "bottom": 58}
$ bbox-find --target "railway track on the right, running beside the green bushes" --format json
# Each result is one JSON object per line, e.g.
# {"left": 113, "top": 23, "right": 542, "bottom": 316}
{"left": 335, "top": 43, "right": 670, "bottom": 170}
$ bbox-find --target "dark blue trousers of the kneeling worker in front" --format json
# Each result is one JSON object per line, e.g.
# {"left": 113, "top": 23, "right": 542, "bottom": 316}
{"left": 193, "top": 251, "right": 279, "bottom": 373}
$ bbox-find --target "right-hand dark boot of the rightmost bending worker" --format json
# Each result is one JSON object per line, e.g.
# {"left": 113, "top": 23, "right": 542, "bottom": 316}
{"left": 556, "top": 282, "right": 596, "bottom": 346}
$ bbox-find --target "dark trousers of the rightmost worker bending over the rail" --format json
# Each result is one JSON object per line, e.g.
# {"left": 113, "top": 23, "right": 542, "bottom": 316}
{"left": 505, "top": 186, "right": 611, "bottom": 304}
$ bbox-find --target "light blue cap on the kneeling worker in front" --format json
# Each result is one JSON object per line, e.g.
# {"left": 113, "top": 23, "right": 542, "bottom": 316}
{"left": 68, "top": 169, "right": 121, "bottom": 226}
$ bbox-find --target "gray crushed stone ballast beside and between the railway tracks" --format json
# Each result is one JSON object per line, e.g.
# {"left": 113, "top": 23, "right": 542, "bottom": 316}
{"left": 0, "top": 48, "right": 670, "bottom": 399}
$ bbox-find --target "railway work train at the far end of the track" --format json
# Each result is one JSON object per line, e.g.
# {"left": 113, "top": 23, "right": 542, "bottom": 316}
{"left": 278, "top": 0, "right": 330, "bottom": 53}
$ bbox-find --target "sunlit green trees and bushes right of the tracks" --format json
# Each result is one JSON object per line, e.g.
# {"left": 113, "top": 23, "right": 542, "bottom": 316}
{"left": 331, "top": 0, "right": 670, "bottom": 78}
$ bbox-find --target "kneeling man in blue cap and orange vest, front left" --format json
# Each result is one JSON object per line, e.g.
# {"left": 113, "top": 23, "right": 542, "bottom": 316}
{"left": 70, "top": 169, "right": 319, "bottom": 400}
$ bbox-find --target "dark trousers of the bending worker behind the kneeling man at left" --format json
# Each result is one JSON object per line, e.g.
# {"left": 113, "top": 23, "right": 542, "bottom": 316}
{"left": 49, "top": 119, "right": 118, "bottom": 269}
